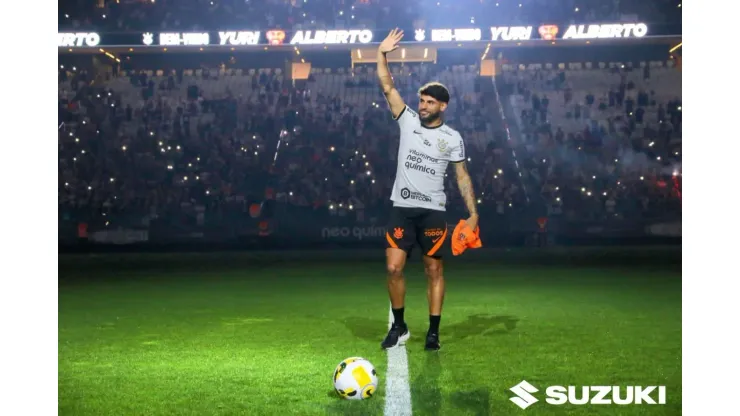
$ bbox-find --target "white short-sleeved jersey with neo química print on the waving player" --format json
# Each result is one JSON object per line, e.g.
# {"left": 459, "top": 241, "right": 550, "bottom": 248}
{"left": 391, "top": 106, "right": 465, "bottom": 211}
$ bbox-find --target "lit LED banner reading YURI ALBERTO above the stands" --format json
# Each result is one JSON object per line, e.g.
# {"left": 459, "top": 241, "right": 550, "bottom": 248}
{"left": 57, "top": 23, "right": 660, "bottom": 48}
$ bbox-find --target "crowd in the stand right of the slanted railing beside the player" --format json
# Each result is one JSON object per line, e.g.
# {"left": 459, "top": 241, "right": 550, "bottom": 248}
{"left": 502, "top": 61, "right": 682, "bottom": 219}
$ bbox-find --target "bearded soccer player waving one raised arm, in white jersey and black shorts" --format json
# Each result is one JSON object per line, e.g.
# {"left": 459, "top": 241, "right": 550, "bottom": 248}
{"left": 377, "top": 29, "right": 478, "bottom": 350}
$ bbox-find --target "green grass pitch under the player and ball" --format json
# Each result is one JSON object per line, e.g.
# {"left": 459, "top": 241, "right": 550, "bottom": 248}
{"left": 59, "top": 251, "right": 681, "bottom": 416}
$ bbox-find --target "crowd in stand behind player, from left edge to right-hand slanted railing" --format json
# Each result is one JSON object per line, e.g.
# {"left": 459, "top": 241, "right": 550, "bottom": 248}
{"left": 59, "top": 61, "right": 524, "bottom": 228}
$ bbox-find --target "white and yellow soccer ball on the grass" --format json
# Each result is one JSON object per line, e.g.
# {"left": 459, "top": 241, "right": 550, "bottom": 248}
{"left": 334, "top": 357, "right": 378, "bottom": 400}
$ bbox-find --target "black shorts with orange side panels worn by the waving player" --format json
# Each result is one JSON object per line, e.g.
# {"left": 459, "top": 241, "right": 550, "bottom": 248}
{"left": 385, "top": 207, "right": 447, "bottom": 258}
